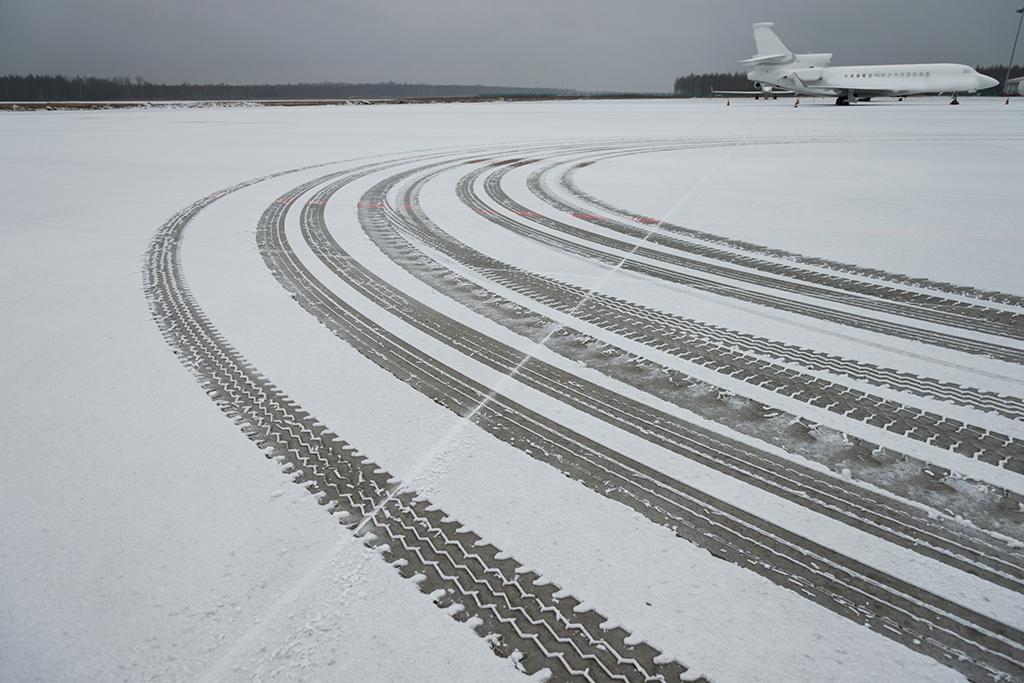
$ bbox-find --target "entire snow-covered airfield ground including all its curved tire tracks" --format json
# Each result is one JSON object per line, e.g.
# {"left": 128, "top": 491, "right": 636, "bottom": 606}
{"left": 0, "top": 99, "right": 1024, "bottom": 680}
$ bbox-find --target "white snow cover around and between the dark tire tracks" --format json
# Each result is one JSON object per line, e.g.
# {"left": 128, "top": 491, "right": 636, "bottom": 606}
{"left": 0, "top": 98, "right": 1024, "bottom": 681}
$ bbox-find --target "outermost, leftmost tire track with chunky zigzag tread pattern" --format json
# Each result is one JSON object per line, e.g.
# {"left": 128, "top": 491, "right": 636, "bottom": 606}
{"left": 143, "top": 161, "right": 700, "bottom": 681}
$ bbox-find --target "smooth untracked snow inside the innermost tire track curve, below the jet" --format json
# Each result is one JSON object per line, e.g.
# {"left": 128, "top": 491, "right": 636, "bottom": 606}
{"left": 577, "top": 134, "right": 1024, "bottom": 294}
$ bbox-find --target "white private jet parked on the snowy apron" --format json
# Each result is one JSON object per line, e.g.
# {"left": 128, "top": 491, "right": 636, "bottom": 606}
{"left": 739, "top": 23, "right": 999, "bottom": 104}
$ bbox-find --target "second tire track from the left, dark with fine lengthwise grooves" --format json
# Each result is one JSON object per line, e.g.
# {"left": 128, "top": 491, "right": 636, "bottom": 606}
{"left": 251, "top": 152, "right": 1024, "bottom": 679}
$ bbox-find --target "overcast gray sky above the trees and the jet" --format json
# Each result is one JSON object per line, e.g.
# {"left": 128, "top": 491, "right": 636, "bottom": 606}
{"left": 0, "top": 0, "right": 1022, "bottom": 90}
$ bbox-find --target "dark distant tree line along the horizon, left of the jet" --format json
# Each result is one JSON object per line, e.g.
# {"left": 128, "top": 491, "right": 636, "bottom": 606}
{"left": 0, "top": 75, "right": 565, "bottom": 102}
